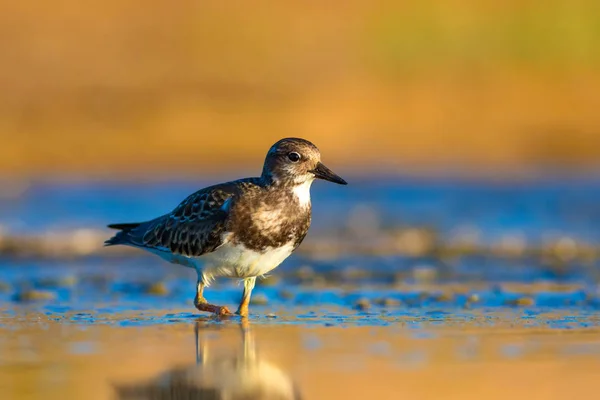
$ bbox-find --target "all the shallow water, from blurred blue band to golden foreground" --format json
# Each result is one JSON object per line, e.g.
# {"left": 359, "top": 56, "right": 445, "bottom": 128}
{"left": 0, "top": 180, "right": 600, "bottom": 399}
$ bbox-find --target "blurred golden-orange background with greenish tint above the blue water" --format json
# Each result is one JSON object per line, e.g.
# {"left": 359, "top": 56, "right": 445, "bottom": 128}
{"left": 0, "top": 0, "right": 600, "bottom": 178}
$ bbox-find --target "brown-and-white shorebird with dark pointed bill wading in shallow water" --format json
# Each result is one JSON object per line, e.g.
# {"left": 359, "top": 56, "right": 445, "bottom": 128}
{"left": 104, "top": 138, "right": 347, "bottom": 317}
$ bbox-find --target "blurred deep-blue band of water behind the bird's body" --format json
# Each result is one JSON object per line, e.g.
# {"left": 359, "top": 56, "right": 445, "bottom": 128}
{"left": 0, "top": 178, "right": 600, "bottom": 244}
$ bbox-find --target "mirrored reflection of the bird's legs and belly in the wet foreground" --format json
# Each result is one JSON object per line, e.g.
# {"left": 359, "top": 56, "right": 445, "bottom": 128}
{"left": 117, "top": 319, "right": 301, "bottom": 400}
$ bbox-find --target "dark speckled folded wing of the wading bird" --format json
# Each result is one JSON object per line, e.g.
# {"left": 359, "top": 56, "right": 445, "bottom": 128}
{"left": 115, "top": 182, "right": 237, "bottom": 257}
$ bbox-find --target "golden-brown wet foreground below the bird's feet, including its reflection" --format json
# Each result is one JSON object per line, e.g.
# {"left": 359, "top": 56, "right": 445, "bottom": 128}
{"left": 0, "top": 311, "right": 600, "bottom": 400}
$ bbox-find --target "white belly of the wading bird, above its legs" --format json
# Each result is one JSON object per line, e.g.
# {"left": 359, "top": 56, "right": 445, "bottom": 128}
{"left": 197, "top": 243, "right": 294, "bottom": 279}
